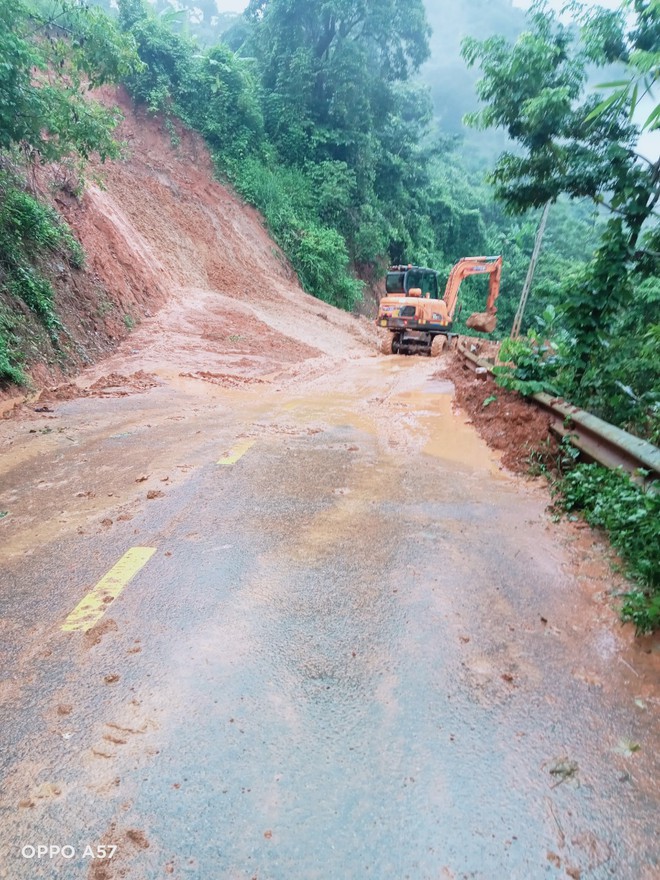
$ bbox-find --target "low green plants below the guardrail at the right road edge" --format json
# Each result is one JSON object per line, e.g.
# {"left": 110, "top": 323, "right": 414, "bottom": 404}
{"left": 555, "top": 464, "right": 660, "bottom": 633}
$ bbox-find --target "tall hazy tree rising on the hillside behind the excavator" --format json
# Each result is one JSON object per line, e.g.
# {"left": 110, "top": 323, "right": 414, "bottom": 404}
{"left": 235, "top": 0, "right": 431, "bottom": 264}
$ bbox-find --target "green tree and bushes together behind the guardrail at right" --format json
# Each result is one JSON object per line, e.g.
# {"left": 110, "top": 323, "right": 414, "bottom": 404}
{"left": 464, "top": 0, "right": 660, "bottom": 438}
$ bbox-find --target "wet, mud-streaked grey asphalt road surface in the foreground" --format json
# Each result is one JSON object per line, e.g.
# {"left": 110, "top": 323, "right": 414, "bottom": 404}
{"left": 0, "top": 358, "right": 660, "bottom": 880}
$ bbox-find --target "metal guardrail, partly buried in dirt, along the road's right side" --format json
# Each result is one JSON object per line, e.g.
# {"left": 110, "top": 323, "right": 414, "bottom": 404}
{"left": 458, "top": 344, "right": 660, "bottom": 485}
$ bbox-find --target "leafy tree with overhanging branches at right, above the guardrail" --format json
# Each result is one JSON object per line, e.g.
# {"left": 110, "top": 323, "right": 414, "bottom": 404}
{"left": 463, "top": 0, "right": 660, "bottom": 390}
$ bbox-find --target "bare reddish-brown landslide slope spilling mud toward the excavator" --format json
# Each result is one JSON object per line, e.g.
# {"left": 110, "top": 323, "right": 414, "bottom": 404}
{"left": 1, "top": 90, "right": 375, "bottom": 412}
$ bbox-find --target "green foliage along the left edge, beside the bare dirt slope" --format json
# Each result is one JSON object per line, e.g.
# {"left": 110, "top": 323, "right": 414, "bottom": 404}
{"left": 0, "top": 0, "right": 139, "bottom": 382}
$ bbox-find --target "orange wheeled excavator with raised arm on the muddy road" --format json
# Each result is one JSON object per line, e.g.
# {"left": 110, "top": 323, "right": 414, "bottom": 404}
{"left": 376, "top": 256, "right": 502, "bottom": 357}
